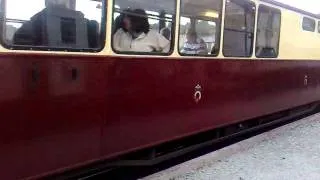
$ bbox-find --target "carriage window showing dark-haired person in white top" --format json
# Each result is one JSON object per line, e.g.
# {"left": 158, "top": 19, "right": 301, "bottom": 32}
{"left": 112, "top": 0, "right": 176, "bottom": 55}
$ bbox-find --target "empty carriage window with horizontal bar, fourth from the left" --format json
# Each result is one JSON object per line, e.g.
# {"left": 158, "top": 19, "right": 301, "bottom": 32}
{"left": 223, "top": 0, "right": 255, "bottom": 57}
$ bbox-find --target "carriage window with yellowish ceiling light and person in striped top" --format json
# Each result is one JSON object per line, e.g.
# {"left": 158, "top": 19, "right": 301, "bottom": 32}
{"left": 179, "top": 0, "right": 222, "bottom": 56}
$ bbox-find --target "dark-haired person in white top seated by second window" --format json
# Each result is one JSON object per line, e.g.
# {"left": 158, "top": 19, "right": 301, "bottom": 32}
{"left": 113, "top": 9, "right": 170, "bottom": 53}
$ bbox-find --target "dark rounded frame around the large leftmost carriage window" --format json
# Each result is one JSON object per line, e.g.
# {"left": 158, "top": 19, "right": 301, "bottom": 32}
{"left": 0, "top": 0, "right": 107, "bottom": 53}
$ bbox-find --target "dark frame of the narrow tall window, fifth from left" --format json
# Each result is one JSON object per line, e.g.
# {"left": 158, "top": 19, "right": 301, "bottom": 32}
{"left": 254, "top": 4, "right": 282, "bottom": 59}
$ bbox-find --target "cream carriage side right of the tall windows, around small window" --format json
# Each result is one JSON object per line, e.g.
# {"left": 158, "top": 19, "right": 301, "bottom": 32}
{"left": 260, "top": 0, "right": 320, "bottom": 60}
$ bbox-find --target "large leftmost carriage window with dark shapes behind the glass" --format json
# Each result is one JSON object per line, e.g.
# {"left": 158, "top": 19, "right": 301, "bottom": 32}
{"left": 2, "top": 0, "right": 105, "bottom": 51}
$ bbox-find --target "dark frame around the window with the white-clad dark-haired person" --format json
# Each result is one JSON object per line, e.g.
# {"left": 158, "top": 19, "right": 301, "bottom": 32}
{"left": 109, "top": 0, "right": 178, "bottom": 56}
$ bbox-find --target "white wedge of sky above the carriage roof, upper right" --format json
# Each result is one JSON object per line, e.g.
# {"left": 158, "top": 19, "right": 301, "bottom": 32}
{"left": 276, "top": 0, "right": 320, "bottom": 14}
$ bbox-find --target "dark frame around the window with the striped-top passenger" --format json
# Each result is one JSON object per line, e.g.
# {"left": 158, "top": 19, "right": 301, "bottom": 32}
{"left": 177, "top": 0, "right": 224, "bottom": 57}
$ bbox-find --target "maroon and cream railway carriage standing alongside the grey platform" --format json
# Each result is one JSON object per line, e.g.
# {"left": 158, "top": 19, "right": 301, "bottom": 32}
{"left": 0, "top": 0, "right": 320, "bottom": 179}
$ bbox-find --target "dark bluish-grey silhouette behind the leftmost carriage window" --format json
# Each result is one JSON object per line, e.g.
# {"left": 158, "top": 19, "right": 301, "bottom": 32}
{"left": 13, "top": 0, "right": 99, "bottom": 49}
